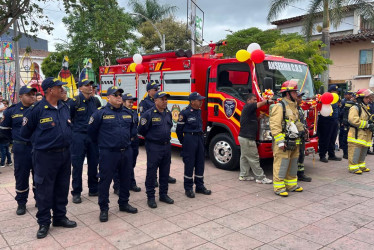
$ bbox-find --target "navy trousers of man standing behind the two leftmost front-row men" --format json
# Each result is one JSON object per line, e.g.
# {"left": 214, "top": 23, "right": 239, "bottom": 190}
{"left": 71, "top": 132, "right": 99, "bottom": 195}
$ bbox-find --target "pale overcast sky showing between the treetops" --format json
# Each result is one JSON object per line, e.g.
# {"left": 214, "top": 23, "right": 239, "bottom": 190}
{"left": 38, "top": 0, "right": 307, "bottom": 51}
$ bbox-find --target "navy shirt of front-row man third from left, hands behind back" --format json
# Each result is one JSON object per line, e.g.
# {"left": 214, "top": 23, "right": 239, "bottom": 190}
{"left": 138, "top": 107, "right": 173, "bottom": 143}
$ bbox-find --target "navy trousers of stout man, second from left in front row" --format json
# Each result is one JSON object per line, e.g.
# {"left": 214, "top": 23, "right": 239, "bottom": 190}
{"left": 99, "top": 147, "right": 132, "bottom": 211}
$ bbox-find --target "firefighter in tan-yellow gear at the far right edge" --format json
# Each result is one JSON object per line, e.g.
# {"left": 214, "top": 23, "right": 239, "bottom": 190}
{"left": 347, "top": 89, "right": 374, "bottom": 174}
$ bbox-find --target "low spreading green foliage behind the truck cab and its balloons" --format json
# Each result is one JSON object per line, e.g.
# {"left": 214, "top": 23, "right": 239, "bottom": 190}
{"left": 218, "top": 27, "right": 301, "bottom": 57}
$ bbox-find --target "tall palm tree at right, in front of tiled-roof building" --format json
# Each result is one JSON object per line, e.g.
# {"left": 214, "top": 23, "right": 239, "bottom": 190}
{"left": 267, "top": 0, "right": 374, "bottom": 89}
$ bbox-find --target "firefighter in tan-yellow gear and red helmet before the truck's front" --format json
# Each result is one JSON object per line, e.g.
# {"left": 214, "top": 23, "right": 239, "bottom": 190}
{"left": 270, "top": 81, "right": 304, "bottom": 197}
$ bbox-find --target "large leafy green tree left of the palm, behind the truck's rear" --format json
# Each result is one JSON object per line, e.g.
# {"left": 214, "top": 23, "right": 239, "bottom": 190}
{"left": 58, "top": 0, "right": 136, "bottom": 74}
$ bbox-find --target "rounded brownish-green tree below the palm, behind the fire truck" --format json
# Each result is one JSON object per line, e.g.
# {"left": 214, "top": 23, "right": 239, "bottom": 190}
{"left": 138, "top": 16, "right": 190, "bottom": 53}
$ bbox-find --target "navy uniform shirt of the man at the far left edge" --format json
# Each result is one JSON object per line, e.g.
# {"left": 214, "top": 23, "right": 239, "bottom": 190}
{"left": 0, "top": 102, "right": 30, "bottom": 142}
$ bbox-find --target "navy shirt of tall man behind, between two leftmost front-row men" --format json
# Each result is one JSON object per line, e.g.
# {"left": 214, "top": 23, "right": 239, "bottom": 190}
{"left": 69, "top": 93, "right": 98, "bottom": 132}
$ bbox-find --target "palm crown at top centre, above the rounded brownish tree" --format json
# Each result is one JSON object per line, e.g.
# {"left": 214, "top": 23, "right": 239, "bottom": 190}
{"left": 129, "top": 0, "right": 178, "bottom": 23}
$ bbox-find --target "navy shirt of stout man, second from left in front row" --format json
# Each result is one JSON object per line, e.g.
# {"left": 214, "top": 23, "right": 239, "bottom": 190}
{"left": 88, "top": 103, "right": 134, "bottom": 149}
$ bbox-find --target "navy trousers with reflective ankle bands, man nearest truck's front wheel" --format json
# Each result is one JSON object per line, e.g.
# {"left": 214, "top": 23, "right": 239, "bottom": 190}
{"left": 182, "top": 133, "right": 205, "bottom": 190}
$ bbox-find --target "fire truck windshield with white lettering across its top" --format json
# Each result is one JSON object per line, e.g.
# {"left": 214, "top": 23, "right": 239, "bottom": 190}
{"left": 256, "top": 61, "right": 315, "bottom": 98}
